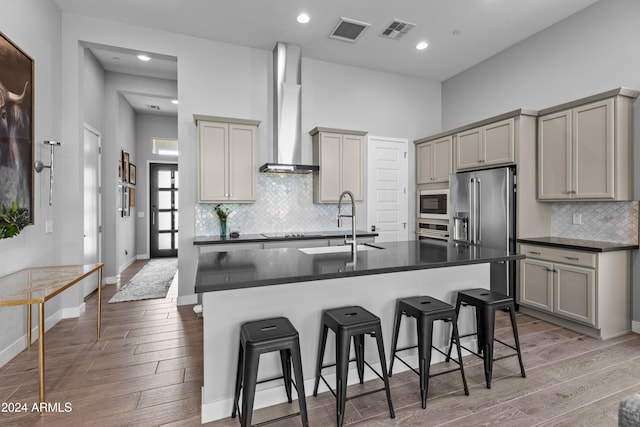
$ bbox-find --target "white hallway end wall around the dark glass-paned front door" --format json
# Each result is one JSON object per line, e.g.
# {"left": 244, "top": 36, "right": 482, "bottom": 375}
{"left": 135, "top": 113, "right": 178, "bottom": 258}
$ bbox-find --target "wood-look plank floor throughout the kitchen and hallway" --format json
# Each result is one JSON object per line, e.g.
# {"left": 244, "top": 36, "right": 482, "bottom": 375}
{"left": 0, "top": 262, "right": 640, "bottom": 427}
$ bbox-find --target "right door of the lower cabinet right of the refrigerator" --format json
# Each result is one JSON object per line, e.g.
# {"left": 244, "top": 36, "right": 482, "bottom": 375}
{"left": 553, "top": 264, "right": 596, "bottom": 326}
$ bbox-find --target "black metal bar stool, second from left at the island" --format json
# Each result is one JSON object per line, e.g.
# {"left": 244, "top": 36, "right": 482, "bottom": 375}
{"left": 313, "top": 306, "right": 395, "bottom": 427}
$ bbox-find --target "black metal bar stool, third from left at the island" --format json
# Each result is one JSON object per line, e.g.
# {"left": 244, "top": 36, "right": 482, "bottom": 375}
{"left": 389, "top": 296, "right": 469, "bottom": 409}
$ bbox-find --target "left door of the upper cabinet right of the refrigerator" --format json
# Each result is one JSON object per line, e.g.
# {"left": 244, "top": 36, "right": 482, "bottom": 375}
{"left": 538, "top": 111, "right": 572, "bottom": 200}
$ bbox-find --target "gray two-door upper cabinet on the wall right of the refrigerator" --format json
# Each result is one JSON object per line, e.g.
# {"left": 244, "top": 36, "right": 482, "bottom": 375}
{"left": 538, "top": 88, "right": 638, "bottom": 201}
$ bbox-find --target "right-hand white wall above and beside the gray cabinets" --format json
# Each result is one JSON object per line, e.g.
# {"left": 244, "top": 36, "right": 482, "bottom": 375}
{"left": 442, "top": 0, "right": 640, "bottom": 330}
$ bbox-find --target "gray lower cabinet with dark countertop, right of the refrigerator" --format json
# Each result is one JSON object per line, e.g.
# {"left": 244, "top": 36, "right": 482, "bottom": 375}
{"left": 518, "top": 244, "right": 631, "bottom": 339}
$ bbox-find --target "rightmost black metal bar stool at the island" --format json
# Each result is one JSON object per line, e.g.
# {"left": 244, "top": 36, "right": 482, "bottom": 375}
{"left": 447, "top": 288, "right": 527, "bottom": 388}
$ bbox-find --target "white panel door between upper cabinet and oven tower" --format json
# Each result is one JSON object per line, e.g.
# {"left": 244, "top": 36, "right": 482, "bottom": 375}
{"left": 367, "top": 136, "right": 409, "bottom": 242}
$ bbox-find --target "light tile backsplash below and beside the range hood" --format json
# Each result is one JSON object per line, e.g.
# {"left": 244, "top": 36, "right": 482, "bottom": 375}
{"left": 195, "top": 174, "right": 364, "bottom": 236}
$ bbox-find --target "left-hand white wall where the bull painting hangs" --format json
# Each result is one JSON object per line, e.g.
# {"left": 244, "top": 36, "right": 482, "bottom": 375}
{"left": 0, "top": 0, "right": 67, "bottom": 366}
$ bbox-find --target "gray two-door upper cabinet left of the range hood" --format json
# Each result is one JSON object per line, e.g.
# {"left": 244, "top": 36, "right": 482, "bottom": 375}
{"left": 194, "top": 115, "right": 260, "bottom": 203}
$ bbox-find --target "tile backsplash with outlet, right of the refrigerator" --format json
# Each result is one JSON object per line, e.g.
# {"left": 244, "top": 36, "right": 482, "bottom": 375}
{"left": 551, "top": 201, "right": 638, "bottom": 244}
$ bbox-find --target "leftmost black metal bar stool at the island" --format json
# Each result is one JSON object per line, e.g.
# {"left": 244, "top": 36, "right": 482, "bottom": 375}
{"left": 231, "top": 317, "right": 309, "bottom": 427}
